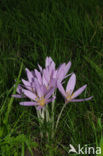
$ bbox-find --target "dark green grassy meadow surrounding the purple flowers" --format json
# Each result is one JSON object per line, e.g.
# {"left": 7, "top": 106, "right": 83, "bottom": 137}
{"left": 0, "top": 0, "right": 103, "bottom": 156}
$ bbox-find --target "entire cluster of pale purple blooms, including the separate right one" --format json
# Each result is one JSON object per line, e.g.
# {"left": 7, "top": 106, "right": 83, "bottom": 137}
{"left": 13, "top": 57, "right": 92, "bottom": 110}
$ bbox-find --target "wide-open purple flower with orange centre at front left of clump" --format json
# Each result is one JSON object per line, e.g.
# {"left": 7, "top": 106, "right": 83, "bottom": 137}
{"left": 12, "top": 79, "right": 54, "bottom": 109}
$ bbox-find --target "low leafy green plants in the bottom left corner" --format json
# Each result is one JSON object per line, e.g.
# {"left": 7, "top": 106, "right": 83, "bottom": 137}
{"left": 0, "top": 134, "right": 37, "bottom": 156}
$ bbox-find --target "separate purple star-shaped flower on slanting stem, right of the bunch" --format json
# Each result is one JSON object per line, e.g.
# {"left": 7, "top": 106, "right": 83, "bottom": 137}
{"left": 57, "top": 74, "right": 93, "bottom": 103}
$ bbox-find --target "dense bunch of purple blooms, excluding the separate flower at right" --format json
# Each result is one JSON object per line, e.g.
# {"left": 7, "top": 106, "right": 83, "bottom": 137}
{"left": 12, "top": 57, "right": 71, "bottom": 109}
